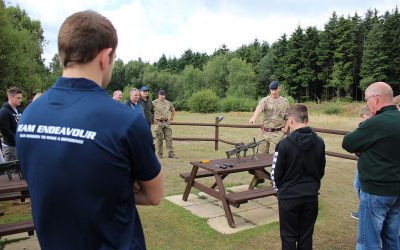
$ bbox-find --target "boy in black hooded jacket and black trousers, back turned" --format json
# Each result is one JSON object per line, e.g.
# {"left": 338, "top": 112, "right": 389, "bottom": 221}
{"left": 271, "top": 104, "right": 325, "bottom": 249}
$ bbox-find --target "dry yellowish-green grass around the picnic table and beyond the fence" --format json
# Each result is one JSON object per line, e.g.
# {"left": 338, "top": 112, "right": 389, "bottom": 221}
{"left": 0, "top": 103, "right": 358, "bottom": 250}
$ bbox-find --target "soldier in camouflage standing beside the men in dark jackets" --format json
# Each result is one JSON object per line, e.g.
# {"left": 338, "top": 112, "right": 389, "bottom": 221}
{"left": 153, "top": 90, "right": 177, "bottom": 158}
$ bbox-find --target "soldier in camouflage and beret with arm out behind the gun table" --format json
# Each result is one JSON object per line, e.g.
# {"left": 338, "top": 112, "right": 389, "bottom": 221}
{"left": 249, "top": 81, "right": 289, "bottom": 185}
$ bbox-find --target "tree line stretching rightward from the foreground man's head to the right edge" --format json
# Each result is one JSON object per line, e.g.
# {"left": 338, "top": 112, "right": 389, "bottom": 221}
{"left": 110, "top": 7, "right": 400, "bottom": 108}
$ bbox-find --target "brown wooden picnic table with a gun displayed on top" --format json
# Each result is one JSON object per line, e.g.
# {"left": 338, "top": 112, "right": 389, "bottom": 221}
{"left": 181, "top": 154, "right": 276, "bottom": 228}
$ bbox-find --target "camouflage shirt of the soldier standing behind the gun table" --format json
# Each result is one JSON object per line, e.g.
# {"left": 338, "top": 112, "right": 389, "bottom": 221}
{"left": 258, "top": 96, "right": 289, "bottom": 128}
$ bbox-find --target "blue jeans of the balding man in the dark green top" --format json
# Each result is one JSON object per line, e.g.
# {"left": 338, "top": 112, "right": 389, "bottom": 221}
{"left": 356, "top": 190, "right": 400, "bottom": 250}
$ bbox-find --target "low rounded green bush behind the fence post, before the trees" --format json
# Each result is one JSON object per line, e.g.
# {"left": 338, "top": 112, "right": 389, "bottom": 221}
{"left": 188, "top": 89, "right": 218, "bottom": 113}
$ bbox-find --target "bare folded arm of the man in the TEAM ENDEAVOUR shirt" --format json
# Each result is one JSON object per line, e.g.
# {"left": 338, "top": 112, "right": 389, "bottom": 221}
{"left": 133, "top": 172, "right": 164, "bottom": 206}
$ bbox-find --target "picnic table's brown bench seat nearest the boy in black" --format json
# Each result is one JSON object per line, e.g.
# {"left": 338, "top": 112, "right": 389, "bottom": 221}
{"left": 226, "top": 187, "right": 277, "bottom": 207}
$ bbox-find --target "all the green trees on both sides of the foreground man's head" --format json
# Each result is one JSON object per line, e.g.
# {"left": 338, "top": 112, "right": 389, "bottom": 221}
{"left": 0, "top": 0, "right": 400, "bottom": 109}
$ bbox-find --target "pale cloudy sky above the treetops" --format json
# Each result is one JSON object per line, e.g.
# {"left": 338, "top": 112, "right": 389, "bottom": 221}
{"left": 5, "top": 0, "right": 400, "bottom": 63}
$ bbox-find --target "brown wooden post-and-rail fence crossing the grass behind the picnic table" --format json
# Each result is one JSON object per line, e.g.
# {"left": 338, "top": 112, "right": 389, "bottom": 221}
{"left": 171, "top": 116, "right": 358, "bottom": 160}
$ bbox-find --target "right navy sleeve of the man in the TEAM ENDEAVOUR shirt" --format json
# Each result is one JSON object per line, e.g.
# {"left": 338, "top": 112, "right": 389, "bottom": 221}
{"left": 125, "top": 115, "right": 161, "bottom": 181}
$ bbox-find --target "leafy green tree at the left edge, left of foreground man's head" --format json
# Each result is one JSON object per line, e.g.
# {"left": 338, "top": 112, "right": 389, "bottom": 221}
{"left": 0, "top": 1, "right": 49, "bottom": 98}
